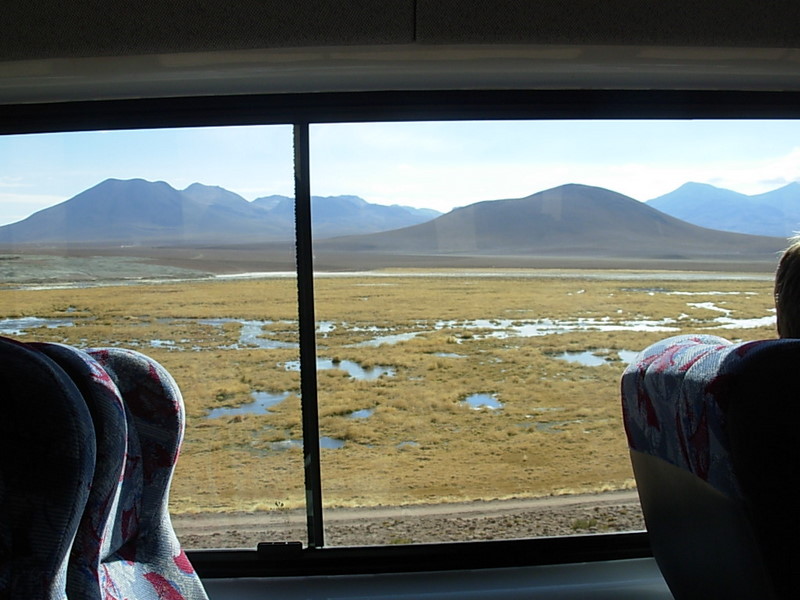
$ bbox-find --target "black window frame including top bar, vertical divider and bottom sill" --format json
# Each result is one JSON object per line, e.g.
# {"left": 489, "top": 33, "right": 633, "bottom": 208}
{"left": 0, "top": 90, "right": 800, "bottom": 578}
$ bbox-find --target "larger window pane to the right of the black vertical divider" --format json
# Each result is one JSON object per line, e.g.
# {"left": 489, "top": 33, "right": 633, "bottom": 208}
{"left": 311, "top": 121, "right": 784, "bottom": 545}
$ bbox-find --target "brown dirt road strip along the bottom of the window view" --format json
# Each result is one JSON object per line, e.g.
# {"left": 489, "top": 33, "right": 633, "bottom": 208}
{"left": 173, "top": 491, "right": 644, "bottom": 548}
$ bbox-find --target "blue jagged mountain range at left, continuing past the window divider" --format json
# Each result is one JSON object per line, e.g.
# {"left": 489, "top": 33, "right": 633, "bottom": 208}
{"left": 0, "top": 179, "right": 439, "bottom": 245}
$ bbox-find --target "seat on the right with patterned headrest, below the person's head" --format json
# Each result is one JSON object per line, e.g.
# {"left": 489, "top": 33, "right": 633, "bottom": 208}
{"left": 621, "top": 335, "right": 800, "bottom": 600}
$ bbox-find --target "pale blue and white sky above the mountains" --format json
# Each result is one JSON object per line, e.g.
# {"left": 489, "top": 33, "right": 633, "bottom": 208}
{"left": 0, "top": 120, "right": 800, "bottom": 225}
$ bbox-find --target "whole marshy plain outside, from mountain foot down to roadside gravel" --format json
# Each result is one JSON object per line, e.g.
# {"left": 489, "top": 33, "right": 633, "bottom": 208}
{"left": 0, "top": 250, "right": 775, "bottom": 547}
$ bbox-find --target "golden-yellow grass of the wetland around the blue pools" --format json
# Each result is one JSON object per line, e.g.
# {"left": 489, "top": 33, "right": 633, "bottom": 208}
{"left": 0, "top": 270, "right": 775, "bottom": 513}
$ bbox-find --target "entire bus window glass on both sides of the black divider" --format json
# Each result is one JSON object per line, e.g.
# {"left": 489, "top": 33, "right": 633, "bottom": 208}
{"left": 0, "top": 121, "right": 788, "bottom": 548}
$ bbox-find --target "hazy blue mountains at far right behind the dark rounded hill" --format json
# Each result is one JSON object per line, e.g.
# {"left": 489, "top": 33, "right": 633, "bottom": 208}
{"left": 647, "top": 182, "right": 800, "bottom": 238}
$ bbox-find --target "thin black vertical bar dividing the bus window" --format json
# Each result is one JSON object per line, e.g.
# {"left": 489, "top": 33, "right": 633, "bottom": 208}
{"left": 293, "top": 121, "right": 325, "bottom": 548}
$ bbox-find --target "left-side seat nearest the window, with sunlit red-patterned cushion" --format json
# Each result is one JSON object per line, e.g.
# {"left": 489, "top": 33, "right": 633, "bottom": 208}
{"left": 88, "top": 348, "right": 207, "bottom": 600}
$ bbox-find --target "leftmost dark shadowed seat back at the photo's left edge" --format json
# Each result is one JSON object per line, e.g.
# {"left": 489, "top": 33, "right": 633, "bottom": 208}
{"left": 0, "top": 338, "right": 95, "bottom": 600}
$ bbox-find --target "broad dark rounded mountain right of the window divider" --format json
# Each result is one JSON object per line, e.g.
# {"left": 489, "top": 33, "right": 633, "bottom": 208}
{"left": 317, "top": 184, "right": 785, "bottom": 259}
